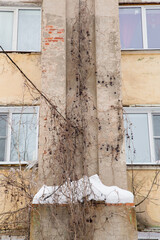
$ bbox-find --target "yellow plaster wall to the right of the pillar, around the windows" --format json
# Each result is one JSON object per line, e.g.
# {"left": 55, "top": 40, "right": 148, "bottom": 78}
{"left": 119, "top": 0, "right": 160, "bottom": 230}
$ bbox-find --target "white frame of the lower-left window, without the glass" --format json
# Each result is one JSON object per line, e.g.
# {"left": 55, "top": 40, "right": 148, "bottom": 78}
{"left": 0, "top": 106, "right": 39, "bottom": 165}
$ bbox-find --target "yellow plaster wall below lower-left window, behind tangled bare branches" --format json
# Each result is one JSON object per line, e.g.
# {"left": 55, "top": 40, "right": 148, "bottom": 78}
{"left": 0, "top": 166, "right": 37, "bottom": 235}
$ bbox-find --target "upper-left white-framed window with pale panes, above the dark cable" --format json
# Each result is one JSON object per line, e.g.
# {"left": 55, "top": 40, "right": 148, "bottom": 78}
{"left": 0, "top": 7, "right": 41, "bottom": 52}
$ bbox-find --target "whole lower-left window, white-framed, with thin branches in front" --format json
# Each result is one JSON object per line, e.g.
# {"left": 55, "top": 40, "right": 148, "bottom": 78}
{"left": 0, "top": 107, "right": 38, "bottom": 164}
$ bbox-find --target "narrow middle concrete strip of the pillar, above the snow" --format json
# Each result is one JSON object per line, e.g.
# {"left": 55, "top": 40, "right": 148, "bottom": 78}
{"left": 66, "top": 0, "right": 98, "bottom": 178}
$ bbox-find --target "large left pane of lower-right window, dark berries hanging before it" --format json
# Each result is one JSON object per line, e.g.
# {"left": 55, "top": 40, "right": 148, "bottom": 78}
{"left": 124, "top": 114, "right": 151, "bottom": 163}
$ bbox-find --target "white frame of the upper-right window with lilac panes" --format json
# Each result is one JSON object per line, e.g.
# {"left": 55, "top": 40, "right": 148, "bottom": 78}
{"left": 119, "top": 5, "right": 160, "bottom": 51}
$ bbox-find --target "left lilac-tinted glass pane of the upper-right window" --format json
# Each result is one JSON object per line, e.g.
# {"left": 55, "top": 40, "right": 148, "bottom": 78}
{"left": 119, "top": 8, "right": 143, "bottom": 49}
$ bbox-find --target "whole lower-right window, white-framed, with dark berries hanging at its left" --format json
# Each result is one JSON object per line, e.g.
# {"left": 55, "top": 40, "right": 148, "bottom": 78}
{"left": 124, "top": 107, "right": 160, "bottom": 164}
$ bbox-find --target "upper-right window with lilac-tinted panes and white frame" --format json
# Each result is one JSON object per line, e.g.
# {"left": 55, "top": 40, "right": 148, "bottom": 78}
{"left": 119, "top": 6, "right": 160, "bottom": 50}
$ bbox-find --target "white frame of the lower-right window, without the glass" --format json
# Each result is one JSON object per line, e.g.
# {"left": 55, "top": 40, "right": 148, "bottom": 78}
{"left": 123, "top": 107, "right": 160, "bottom": 165}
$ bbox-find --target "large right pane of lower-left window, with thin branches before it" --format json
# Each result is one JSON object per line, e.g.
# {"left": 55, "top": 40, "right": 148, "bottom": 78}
{"left": 10, "top": 114, "right": 37, "bottom": 162}
